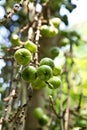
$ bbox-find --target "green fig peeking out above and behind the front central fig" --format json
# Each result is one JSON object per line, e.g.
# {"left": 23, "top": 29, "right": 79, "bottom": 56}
{"left": 40, "top": 57, "right": 54, "bottom": 69}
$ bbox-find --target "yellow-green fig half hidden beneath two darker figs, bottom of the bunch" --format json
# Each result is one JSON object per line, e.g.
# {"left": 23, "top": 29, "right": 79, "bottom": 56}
{"left": 32, "top": 78, "right": 47, "bottom": 89}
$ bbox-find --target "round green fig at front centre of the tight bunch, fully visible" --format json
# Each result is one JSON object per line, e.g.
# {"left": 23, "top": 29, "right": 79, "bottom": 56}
{"left": 37, "top": 65, "right": 52, "bottom": 81}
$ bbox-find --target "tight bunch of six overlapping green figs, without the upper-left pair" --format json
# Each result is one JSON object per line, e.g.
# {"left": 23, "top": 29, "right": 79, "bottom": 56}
{"left": 21, "top": 57, "right": 61, "bottom": 89}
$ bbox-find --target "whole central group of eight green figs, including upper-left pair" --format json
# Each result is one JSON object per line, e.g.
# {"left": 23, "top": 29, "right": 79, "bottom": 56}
{"left": 14, "top": 40, "right": 61, "bottom": 89}
